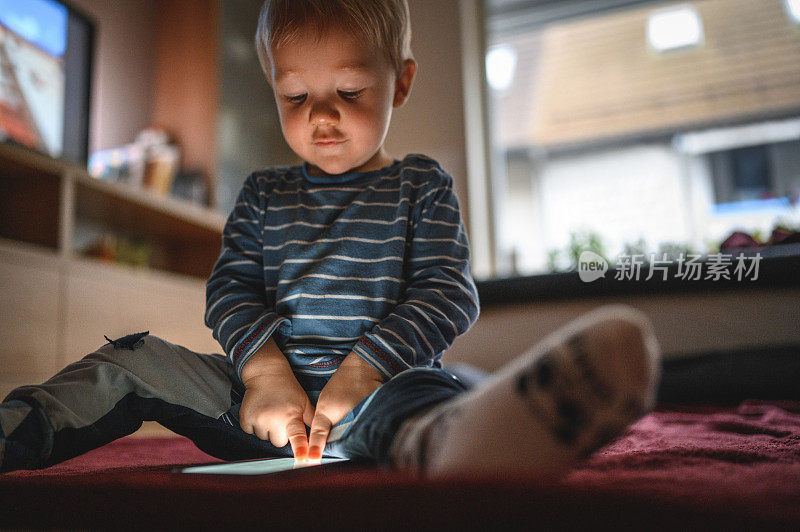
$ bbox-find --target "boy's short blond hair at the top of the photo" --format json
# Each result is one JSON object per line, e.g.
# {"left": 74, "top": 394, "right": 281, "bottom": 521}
{"left": 256, "top": 0, "right": 413, "bottom": 80}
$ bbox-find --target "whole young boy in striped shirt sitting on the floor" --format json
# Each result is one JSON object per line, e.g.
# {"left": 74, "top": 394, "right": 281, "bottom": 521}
{"left": 0, "top": 0, "right": 658, "bottom": 475}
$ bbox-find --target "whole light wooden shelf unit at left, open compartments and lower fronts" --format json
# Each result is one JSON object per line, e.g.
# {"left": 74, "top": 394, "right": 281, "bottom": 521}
{"left": 0, "top": 144, "right": 225, "bottom": 399}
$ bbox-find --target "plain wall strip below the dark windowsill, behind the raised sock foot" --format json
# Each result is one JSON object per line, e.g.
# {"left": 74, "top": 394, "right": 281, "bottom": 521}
{"left": 445, "top": 288, "right": 800, "bottom": 371}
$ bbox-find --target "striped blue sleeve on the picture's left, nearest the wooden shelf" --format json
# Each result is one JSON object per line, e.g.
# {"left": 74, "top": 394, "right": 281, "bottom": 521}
{"left": 205, "top": 174, "right": 291, "bottom": 377}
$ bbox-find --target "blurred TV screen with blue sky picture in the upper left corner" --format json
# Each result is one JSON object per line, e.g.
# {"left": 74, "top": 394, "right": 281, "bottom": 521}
{"left": 0, "top": 0, "right": 94, "bottom": 162}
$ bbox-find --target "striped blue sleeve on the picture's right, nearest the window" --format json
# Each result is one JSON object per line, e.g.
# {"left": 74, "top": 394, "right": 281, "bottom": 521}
{"left": 353, "top": 171, "right": 480, "bottom": 378}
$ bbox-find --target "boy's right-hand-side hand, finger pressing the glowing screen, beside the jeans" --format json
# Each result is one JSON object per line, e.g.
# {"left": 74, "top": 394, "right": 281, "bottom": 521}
{"left": 308, "top": 353, "right": 384, "bottom": 460}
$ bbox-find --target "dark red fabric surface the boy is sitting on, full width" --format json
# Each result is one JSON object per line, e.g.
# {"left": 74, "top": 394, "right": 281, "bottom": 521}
{"left": 0, "top": 401, "right": 800, "bottom": 530}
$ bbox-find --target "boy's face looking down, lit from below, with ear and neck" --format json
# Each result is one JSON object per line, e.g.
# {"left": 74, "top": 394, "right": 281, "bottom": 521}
{"left": 270, "top": 26, "right": 415, "bottom": 175}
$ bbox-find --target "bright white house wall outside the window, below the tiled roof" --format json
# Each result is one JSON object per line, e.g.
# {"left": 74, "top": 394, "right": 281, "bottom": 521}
{"left": 520, "top": 143, "right": 692, "bottom": 272}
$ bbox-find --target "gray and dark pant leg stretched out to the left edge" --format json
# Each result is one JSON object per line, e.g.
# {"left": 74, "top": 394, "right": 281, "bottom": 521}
{"left": 0, "top": 336, "right": 269, "bottom": 471}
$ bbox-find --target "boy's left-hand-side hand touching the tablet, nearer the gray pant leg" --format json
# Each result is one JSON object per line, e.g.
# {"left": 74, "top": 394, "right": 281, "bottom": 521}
{"left": 239, "top": 339, "right": 314, "bottom": 460}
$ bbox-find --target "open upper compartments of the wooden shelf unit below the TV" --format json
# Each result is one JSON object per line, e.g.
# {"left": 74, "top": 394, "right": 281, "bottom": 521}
{"left": 0, "top": 144, "right": 225, "bottom": 278}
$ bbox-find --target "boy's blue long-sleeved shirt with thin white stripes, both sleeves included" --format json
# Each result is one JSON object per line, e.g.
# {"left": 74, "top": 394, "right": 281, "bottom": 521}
{"left": 205, "top": 155, "right": 479, "bottom": 387}
